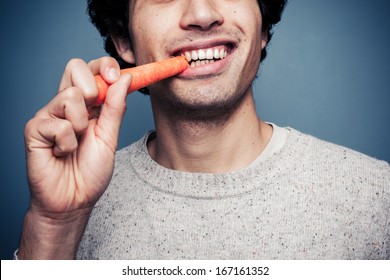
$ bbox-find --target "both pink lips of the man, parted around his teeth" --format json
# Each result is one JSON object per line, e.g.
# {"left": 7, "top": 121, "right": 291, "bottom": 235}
{"left": 171, "top": 39, "right": 237, "bottom": 79}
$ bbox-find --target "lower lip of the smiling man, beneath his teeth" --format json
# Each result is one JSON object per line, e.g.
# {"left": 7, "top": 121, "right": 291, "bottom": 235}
{"left": 176, "top": 50, "right": 231, "bottom": 79}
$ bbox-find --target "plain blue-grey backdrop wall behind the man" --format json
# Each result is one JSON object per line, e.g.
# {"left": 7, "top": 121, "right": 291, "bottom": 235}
{"left": 0, "top": 0, "right": 390, "bottom": 259}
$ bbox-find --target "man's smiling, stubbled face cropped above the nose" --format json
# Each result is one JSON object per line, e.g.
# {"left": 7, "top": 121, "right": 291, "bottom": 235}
{"left": 129, "top": 0, "right": 266, "bottom": 116}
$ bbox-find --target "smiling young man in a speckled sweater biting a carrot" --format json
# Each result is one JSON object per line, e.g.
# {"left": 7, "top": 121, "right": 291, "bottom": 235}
{"left": 18, "top": 0, "right": 390, "bottom": 259}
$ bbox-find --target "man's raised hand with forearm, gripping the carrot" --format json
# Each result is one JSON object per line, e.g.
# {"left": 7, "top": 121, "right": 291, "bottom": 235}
{"left": 19, "top": 57, "right": 131, "bottom": 259}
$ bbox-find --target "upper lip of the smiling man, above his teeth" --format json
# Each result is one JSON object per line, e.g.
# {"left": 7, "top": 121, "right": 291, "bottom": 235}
{"left": 170, "top": 39, "right": 238, "bottom": 56}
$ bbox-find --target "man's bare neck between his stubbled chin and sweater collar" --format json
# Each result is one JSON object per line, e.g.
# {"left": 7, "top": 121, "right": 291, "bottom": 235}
{"left": 148, "top": 93, "right": 272, "bottom": 173}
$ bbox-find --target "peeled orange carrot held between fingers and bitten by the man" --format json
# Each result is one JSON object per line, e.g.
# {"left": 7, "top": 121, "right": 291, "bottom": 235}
{"left": 95, "top": 56, "right": 188, "bottom": 106}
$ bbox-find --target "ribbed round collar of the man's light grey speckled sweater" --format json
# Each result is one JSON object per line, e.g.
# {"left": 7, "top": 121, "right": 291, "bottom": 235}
{"left": 129, "top": 127, "right": 303, "bottom": 199}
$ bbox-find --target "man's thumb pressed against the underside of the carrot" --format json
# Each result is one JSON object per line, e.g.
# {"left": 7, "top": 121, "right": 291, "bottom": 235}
{"left": 95, "top": 74, "right": 132, "bottom": 147}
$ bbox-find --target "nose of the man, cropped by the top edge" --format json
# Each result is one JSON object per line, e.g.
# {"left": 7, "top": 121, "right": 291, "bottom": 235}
{"left": 180, "top": 0, "right": 224, "bottom": 31}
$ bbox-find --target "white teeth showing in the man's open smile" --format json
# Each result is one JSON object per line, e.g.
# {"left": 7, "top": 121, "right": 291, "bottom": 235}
{"left": 180, "top": 45, "right": 231, "bottom": 68}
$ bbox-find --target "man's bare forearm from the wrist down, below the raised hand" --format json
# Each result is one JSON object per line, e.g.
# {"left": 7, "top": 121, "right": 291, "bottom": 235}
{"left": 18, "top": 210, "right": 90, "bottom": 260}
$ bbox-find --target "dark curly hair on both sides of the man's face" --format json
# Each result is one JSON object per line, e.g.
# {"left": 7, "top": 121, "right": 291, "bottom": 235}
{"left": 87, "top": 0, "right": 287, "bottom": 94}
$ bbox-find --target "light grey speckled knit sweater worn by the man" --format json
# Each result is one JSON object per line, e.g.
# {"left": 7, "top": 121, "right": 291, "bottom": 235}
{"left": 77, "top": 128, "right": 390, "bottom": 259}
